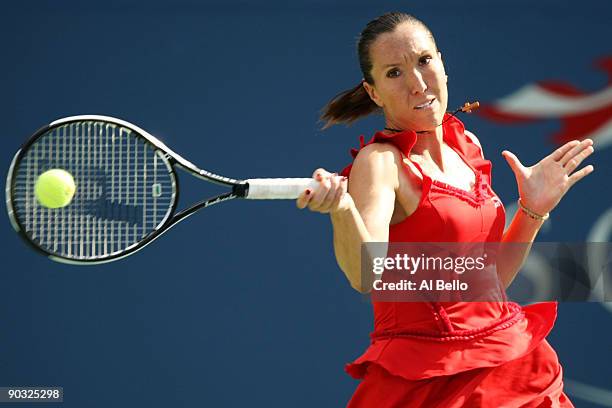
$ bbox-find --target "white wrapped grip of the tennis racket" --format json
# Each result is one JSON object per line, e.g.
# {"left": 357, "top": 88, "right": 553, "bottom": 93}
{"left": 245, "top": 178, "right": 319, "bottom": 200}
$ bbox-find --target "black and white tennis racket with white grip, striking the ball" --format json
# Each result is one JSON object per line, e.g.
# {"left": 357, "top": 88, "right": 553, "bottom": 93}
{"left": 6, "top": 115, "right": 317, "bottom": 264}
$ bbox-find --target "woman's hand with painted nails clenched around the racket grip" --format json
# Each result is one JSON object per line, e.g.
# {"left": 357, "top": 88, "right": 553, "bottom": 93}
{"left": 296, "top": 169, "right": 354, "bottom": 214}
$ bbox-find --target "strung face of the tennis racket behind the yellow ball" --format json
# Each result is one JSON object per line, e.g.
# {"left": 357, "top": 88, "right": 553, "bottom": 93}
{"left": 12, "top": 121, "right": 176, "bottom": 260}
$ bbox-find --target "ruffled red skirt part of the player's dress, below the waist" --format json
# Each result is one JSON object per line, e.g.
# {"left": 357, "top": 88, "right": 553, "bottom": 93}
{"left": 346, "top": 303, "right": 573, "bottom": 408}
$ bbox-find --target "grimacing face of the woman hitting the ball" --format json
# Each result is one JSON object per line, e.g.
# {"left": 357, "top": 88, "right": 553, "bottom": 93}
{"left": 364, "top": 23, "right": 448, "bottom": 131}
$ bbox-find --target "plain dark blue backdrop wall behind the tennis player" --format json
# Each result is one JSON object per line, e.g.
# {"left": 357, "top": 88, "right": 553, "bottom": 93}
{"left": 0, "top": 0, "right": 612, "bottom": 407}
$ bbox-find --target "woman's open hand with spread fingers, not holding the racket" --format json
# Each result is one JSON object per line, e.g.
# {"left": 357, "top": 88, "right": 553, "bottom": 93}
{"left": 502, "top": 139, "right": 593, "bottom": 215}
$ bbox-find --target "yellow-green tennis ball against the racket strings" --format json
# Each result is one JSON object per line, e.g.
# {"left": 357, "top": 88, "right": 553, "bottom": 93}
{"left": 34, "top": 169, "right": 76, "bottom": 208}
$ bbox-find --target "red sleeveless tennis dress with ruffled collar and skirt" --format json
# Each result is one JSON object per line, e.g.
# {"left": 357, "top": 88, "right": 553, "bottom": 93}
{"left": 342, "top": 115, "right": 573, "bottom": 408}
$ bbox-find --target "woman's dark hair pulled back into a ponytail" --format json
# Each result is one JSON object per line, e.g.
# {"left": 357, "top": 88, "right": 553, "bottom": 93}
{"left": 320, "top": 12, "right": 436, "bottom": 129}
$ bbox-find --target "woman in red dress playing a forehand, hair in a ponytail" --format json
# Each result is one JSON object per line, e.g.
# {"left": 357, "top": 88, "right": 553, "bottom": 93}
{"left": 297, "top": 13, "right": 593, "bottom": 408}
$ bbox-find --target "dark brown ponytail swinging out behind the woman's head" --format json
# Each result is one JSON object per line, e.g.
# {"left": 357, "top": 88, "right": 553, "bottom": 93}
{"left": 320, "top": 82, "right": 380, "bottom": 129}
